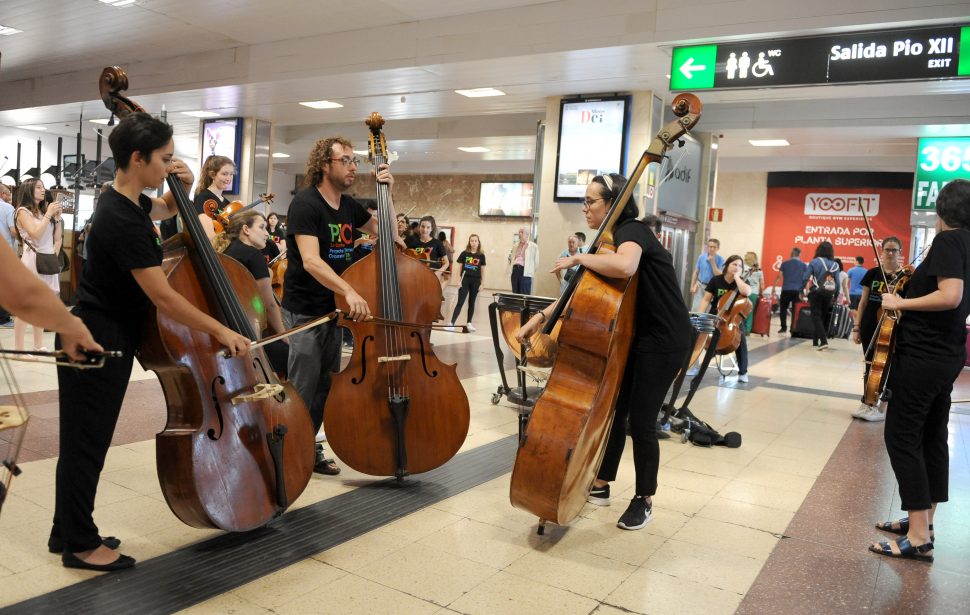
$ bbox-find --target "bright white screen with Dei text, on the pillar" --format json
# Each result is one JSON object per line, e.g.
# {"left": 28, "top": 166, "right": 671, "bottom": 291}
{"left": 554, "top": 96, "right": 630, "bottom": 201}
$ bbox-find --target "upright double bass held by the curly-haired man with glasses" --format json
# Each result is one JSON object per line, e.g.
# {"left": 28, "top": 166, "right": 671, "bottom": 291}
{"left": 323, "top": 113, "right": 469, "bottom": 480}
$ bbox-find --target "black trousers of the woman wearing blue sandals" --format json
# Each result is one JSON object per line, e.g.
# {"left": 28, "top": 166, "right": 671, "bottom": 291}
{"left": 883, "top": 353, "right": 963, "bottom": 510}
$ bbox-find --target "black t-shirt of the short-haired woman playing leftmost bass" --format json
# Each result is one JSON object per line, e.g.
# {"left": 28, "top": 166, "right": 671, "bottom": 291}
{"left": 77, "top": 189, "right": 162, "bottom": 335}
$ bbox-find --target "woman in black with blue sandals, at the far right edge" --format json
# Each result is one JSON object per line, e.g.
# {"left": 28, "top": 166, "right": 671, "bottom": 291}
{"left": 869, "top": 179, "right": 970, "bottom": 562}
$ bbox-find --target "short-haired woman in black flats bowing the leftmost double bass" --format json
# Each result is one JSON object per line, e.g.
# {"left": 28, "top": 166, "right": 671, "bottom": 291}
{"left": 47, "top": 113, "right": 249, "bottom": 571}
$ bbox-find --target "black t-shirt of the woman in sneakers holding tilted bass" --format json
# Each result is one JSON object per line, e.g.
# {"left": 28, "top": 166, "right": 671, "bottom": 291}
{"left": 613, "top": 219, "right": 691, "bottom": 352}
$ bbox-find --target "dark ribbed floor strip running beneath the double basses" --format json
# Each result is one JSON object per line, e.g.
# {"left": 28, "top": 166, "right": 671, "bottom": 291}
{"left": 0, "top": 436, "right": 517, "bottom": 615}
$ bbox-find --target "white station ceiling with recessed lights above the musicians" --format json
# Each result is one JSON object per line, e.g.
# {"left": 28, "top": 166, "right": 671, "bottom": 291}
{"left": 0, "top": 0, "right": 970, "bottom": 173}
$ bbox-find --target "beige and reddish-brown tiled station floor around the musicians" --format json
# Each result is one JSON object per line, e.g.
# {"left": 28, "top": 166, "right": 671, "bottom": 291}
{"left": 0, "top": 304, "right": 970, "bottom": 615}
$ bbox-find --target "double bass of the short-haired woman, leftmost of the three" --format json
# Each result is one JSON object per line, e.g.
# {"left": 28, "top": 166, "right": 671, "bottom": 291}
{"left": 99, "top": 67, "right": 315, "bottom": 531}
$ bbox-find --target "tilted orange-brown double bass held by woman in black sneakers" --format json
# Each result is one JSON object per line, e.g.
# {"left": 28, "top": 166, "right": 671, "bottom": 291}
{"left": 509, "top": 94, "right": 701, "bottom": 533}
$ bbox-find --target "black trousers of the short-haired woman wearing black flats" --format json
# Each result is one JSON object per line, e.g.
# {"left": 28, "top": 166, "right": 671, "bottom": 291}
{"left": 51, "top": 309, "right": 136, "bottom": 553}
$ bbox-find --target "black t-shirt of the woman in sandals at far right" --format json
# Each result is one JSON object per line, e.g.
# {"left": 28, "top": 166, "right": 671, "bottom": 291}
{"left": 892, "top": 230, "right": 970, "bottom": 362}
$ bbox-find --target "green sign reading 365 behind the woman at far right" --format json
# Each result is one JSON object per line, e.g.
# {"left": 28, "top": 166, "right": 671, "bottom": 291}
{"left": 913, "top": 137, "right": 970, "bottom": 211}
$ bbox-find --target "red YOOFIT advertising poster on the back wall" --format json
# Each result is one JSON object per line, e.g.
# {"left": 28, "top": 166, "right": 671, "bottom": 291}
{"left": 762, "top": 188, "right": 912, "bottom": 285}
